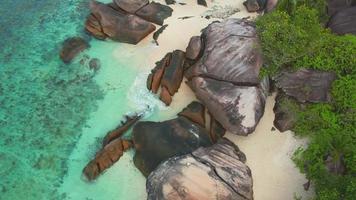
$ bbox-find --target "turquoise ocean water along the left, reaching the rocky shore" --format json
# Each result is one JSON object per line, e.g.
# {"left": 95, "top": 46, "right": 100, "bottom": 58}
{"left": 0, "top": 0, "right": 180, "bottom": 200}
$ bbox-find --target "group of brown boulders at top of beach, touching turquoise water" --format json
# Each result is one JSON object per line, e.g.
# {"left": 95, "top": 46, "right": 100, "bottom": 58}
{"left": 85, "top": 0, "right": 173, "bottom": 44}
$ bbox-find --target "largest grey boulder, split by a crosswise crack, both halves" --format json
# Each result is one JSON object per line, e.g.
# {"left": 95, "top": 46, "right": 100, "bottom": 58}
{"left": 185, "top": 19, "right": 268, "bottom": 135}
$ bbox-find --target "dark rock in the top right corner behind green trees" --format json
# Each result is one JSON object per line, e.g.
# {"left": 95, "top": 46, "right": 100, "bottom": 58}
{"left": 327, "top": 0, "right": 356, "bottom": 35}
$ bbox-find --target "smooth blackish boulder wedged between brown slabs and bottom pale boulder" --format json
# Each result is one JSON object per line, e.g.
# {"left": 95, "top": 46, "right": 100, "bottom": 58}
{"left": 132, "top": 117, "right": 212, "bottom": 176}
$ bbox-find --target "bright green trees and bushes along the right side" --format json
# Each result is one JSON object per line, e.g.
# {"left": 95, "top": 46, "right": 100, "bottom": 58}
{"left": 256, "top": 0, "right": 356, "bottom": 200}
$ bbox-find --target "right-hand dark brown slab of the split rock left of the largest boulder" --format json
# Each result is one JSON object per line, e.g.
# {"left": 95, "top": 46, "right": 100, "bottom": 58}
{"left": 161, "top": 50, "right": 185, "bottom": 96}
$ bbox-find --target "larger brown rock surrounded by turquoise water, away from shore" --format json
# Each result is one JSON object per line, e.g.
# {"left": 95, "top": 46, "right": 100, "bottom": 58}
{"left": 59, "top": 37, "right": 89, "bottom": 63}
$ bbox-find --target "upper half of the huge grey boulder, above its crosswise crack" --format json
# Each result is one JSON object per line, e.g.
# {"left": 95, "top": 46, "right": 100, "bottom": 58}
{"left": 186, "top": 19, "right": 263, "bottom": 85}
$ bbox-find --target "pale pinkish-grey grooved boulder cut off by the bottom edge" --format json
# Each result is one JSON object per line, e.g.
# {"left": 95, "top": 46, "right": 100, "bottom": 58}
{"left": 146, "top": 139, "right": 253, "bottom": 200}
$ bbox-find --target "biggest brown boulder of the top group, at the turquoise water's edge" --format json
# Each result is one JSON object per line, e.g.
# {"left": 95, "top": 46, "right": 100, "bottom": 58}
{"left": 86, "top": 1, "right": 156, "bottom": 44}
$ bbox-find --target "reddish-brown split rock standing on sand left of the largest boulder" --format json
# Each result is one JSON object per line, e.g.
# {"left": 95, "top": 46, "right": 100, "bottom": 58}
{"left": 147, "top": 50, "right": 185, "bottom": 105}
